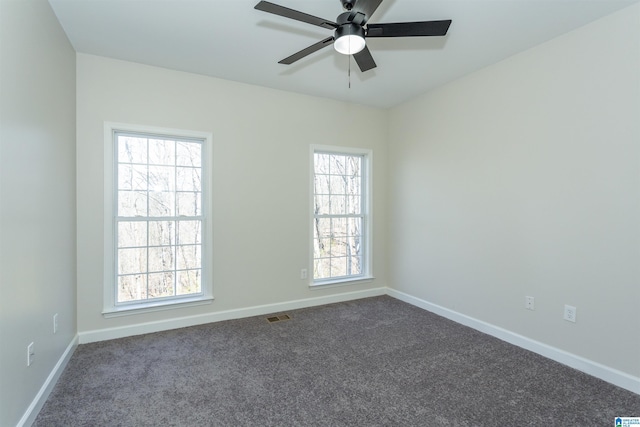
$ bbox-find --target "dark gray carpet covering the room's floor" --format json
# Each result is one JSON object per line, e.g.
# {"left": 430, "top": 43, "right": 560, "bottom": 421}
{"left": 34, "top": 296, "right": 640, "bottom": 427}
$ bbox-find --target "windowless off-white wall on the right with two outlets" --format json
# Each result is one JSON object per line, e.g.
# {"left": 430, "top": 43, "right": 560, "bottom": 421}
{"left": 388, "top": 4, "right": 640, "bottom": 378}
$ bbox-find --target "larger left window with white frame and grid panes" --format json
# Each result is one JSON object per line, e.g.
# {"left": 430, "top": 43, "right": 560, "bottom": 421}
{"left": 105, "top": 122, "right": 211, "bottom": 312}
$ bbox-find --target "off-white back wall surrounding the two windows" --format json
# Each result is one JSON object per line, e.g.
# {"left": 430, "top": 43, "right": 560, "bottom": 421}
{"left": 77, "top": 54, "right": 387, "bottom": 342}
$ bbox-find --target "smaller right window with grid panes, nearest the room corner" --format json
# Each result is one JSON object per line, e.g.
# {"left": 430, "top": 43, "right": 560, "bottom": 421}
{"left": 312, "top": 147, "right": 371, "bottom": 285}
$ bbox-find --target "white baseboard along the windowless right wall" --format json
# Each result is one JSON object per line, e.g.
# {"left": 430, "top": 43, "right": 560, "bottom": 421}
{"left": 387, "top": 288, "right": 640, "bottom": 394}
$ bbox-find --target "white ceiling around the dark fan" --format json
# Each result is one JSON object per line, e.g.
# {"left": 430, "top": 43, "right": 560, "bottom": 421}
{"left": 49, "top": 0, "right": 640, "bottom": 107}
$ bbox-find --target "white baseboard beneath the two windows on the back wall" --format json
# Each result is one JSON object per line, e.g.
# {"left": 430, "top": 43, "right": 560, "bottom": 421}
{"left": 78, "top": 288, "right": 387, "bottom": 344}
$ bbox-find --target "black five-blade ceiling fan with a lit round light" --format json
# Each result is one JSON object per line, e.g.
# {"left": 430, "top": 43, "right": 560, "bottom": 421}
{"left": 255, "top": 0, "right": 451, "bottom": 72}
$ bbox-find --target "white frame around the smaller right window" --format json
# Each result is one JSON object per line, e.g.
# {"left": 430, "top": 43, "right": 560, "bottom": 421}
{"left": 308, "top": 144, "right": 374, "bottom": 289}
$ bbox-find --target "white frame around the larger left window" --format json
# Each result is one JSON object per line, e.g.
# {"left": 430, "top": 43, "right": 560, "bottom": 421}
{"left": 102, "top": 122, "right": 213, "bottom": 318}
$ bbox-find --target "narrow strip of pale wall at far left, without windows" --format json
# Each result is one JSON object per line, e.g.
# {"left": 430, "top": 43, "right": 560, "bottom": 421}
{"left": 0, "top": 0, "right": 76, "bottom": 426}
